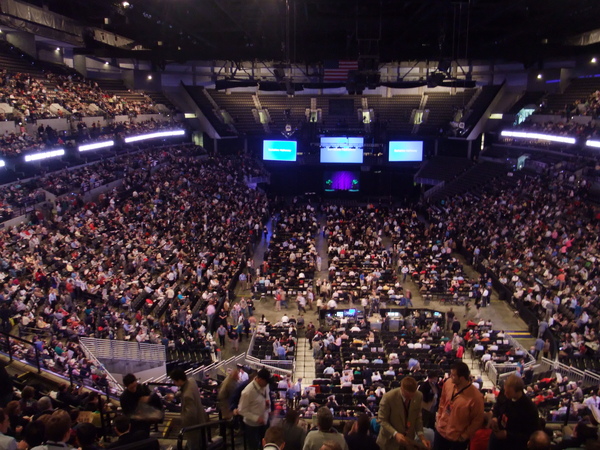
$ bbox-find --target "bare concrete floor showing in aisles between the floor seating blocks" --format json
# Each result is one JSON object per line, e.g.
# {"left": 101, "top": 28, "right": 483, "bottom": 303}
{"left": 222, "top": 216, "right": 535, "bottom": 359}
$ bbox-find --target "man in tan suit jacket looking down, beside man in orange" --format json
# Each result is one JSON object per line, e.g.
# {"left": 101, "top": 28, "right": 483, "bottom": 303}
{"left": 377, "top": 377, "right": 431, "bottom": 450}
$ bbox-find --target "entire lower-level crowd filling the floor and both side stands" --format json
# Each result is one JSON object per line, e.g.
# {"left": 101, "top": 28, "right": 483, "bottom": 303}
{"left": 0, "top": 104, "right": 600, "bottom": 450}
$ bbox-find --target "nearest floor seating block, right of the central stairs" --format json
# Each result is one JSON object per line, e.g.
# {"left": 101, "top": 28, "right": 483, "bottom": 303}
{"left": 300, "top": 321, "right": 455, "bottom": 417}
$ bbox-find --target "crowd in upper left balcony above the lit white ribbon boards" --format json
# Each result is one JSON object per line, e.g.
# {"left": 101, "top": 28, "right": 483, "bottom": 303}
{"left": 0, "top": 64, "right": 180, "bottom": 156}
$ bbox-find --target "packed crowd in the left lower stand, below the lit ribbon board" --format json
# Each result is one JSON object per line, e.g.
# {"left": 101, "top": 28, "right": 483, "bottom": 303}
{"left": 1, "top": 146, "right": 267, "bottom": 390}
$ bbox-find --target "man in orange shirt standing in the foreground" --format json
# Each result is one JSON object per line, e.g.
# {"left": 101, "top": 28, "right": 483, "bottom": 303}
{"left": 433, "top": 361, "right": 483, "bottom": 450}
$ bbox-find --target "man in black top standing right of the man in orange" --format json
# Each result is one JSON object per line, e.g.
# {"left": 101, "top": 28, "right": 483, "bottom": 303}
{"left": 488, "top": 374, "right": 540, "bottom": 450}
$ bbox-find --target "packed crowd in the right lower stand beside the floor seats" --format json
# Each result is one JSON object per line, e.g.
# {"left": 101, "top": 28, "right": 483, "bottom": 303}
{"left": 430, "top": 165, "right": 600, "bottom": 370}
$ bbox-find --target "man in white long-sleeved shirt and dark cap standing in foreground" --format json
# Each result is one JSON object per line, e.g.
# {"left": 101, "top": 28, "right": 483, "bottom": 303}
{"left": 238, "top": 369, "right": 271, "bottom": 450}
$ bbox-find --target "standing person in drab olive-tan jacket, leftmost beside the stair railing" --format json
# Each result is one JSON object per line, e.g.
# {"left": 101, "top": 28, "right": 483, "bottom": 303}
{"left": 171, "top": 369, "right": 208, "bottom": 450}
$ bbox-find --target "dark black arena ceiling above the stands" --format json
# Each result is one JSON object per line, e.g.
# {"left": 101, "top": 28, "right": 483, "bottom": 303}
{"left": 19, "top": 0, "right": 600, "bottom": 65}
